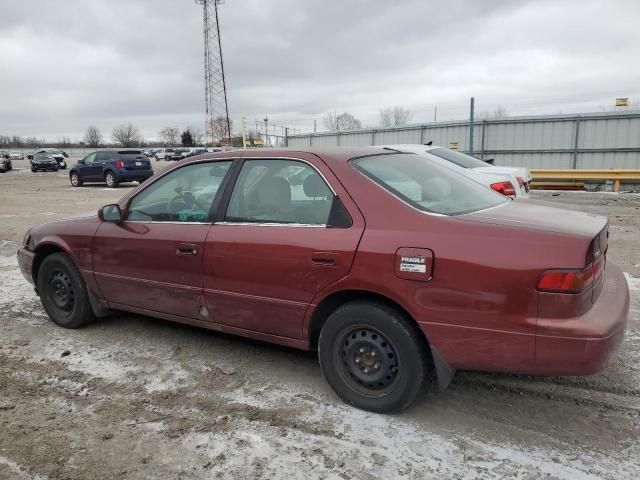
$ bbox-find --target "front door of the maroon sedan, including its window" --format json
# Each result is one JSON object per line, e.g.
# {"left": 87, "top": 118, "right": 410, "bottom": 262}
{"left": 93, "top": 160, "right": 231, "bottom": 318}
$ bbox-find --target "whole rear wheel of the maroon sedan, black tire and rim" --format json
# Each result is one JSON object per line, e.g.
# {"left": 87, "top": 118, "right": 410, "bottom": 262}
{"left": 318, "top": 301, "right": 429, "bottom": 413}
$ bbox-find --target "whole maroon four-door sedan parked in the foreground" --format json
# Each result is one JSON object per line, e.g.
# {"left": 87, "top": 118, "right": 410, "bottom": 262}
{"left": 18, "top": 148, "right": 629, "bottom": 412}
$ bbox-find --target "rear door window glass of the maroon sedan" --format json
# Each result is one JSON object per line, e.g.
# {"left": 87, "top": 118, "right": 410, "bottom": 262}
{"left": 225, "top": 160, "right": 334, "bottom": 225}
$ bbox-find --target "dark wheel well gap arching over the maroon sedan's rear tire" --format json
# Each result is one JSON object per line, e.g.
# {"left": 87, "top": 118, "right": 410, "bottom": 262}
{"left": 309, "top": 290, "right": 430, "bottom": 351}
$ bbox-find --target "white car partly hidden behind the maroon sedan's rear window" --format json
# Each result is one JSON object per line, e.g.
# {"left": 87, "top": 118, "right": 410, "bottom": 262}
{"left": 377, "top": 144, "right": 531, "bottom": 198}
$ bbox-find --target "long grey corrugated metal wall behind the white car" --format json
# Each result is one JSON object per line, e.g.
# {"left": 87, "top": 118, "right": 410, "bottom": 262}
{"left": 287, "top": 111, "right": 640, "bottom": 169}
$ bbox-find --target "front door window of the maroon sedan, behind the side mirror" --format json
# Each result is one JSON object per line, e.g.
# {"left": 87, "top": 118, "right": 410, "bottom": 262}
{"left": 127, "top": 160, "right": 231, "bottom": 223}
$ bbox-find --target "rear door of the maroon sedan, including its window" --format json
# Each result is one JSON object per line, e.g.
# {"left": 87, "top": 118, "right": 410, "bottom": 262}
{"left": 203, "top": 155, "right": 364, "bottom": 339}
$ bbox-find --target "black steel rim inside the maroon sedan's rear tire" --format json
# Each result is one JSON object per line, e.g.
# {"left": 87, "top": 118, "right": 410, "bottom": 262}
{"left": 334, "top": 325, "right": 401, "bottom": 398}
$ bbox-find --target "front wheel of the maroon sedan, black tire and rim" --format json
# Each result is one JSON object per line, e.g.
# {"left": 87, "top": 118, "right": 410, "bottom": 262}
{"left": 38, "top": 253, "right": 95, "bottom": 328}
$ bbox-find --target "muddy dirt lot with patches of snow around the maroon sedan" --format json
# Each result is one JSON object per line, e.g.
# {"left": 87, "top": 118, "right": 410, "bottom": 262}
{"left": 0, "top": 162, "right": 640, "bottom": 479}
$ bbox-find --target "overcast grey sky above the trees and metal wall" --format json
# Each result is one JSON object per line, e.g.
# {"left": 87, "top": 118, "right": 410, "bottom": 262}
{"left": 0, "top": 0, "right": 640, "bottom": 139}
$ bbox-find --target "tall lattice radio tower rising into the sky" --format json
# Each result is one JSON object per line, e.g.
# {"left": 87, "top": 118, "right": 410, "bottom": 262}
{"left": 196, "top": 0, "right": 231, "bottom": 145}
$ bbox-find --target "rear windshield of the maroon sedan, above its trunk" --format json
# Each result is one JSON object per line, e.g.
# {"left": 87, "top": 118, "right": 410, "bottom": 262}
{"left": 352, "top": 154, "right": 509, "bottom": 215}
